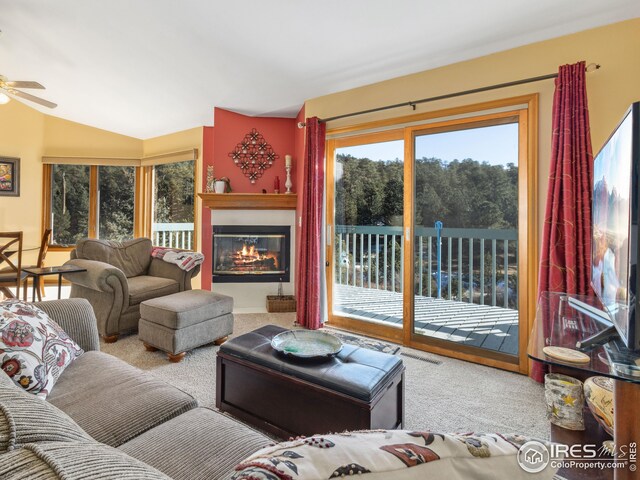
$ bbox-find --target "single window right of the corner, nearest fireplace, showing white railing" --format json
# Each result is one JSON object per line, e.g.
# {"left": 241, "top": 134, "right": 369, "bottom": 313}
{"left": 151, "top": 160, "right": 195, "bottom": 250}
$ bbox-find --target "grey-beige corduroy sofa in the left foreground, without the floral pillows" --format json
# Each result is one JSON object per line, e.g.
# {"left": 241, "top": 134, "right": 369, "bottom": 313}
{"left": 0, "top": 299, "right": 273, "bottom": 480}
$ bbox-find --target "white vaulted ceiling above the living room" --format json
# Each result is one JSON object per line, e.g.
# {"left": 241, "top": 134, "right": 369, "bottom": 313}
{"left": 0, "top": 0, "right": 640, "bottom": 138}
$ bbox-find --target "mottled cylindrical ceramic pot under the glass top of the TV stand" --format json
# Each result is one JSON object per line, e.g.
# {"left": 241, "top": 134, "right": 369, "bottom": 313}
{"left": 544, "top": 373, "right": 584, "bottom": 430}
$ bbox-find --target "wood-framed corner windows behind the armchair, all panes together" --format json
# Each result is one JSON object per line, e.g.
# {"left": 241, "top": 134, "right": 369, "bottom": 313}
{"left": 43, "top": 149, "right": 198, "bottom": 250}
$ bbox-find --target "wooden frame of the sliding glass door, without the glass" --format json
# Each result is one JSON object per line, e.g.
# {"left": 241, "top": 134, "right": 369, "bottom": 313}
{"left": 326, "top": 94, "right": 539, "bottom": 374}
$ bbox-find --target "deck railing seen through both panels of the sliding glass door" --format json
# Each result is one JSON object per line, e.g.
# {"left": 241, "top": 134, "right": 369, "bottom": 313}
{"left": 334, "top": 225, "right": 518, "bottom": 308}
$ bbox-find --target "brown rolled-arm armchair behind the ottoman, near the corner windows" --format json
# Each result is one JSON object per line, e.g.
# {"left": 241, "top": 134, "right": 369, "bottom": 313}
{"left": 64, "top": 238, "right": 200, "bottom": 343}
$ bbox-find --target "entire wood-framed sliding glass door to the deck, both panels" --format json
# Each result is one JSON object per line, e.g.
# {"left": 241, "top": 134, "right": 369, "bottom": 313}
{"left": 326, "top": 96, "right": 537, "bottom": 372}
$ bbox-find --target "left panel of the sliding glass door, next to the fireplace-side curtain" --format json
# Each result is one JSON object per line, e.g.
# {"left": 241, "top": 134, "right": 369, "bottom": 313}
{"left": 329, "top": 131, "right": 404, "bottom": 338}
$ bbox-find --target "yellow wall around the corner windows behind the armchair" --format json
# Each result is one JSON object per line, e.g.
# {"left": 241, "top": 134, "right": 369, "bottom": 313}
{"left": 0, "top": 100, "right": 202, "bottom": 276}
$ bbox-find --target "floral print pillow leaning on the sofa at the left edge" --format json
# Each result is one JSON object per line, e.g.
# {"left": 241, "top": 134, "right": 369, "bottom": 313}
{"left": 0, "top": 300, "right": 84, "bottom": 398}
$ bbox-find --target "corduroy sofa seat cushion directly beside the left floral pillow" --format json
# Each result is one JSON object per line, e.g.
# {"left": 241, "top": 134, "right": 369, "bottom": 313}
{"left": 47, "top": 352, "right": 197, "bottom": 447}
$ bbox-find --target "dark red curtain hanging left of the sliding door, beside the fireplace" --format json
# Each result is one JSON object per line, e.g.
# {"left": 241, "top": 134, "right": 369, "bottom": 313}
{"left": 296, "top": 117, "right": 326, "bottom": 330}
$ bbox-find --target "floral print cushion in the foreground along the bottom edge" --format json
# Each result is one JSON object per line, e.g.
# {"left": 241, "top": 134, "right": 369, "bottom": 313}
{"left": 233, "top": 430, "right": 553, "bottom": 480}
